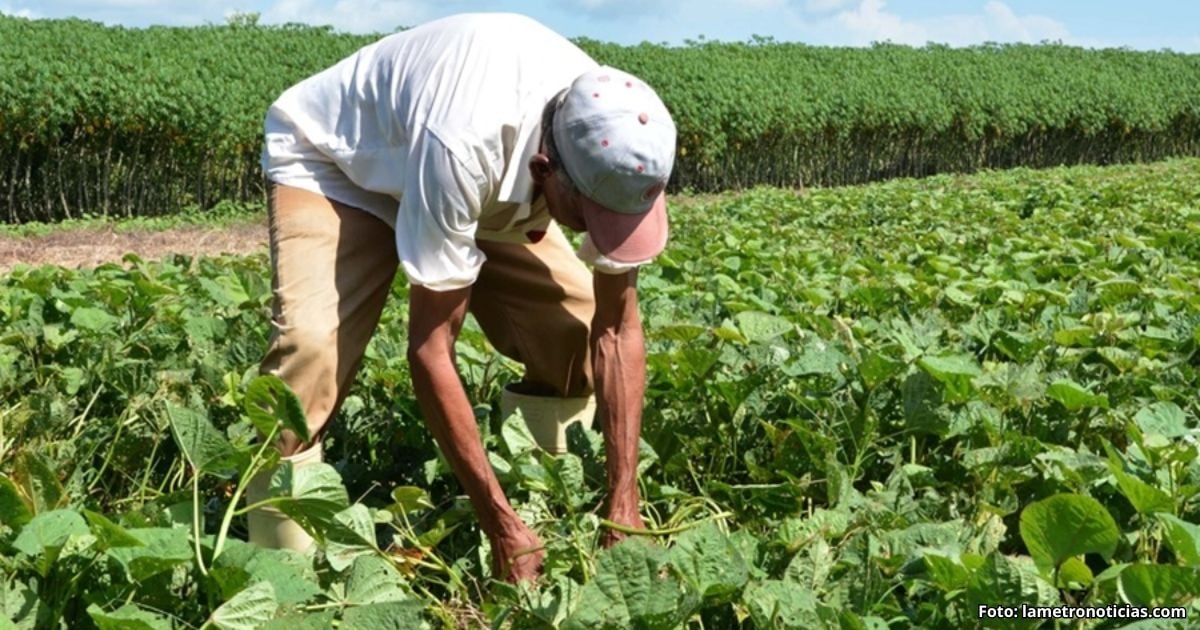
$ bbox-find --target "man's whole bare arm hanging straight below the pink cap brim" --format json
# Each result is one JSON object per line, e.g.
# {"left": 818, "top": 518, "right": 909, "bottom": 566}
{"left": 592, "top": 269, "right": 646, "bottom": 546}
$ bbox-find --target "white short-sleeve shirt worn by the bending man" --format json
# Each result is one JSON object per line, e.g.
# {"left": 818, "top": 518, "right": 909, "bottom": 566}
{"left": 263, "top": 13, "right": 633, "bottom": 290}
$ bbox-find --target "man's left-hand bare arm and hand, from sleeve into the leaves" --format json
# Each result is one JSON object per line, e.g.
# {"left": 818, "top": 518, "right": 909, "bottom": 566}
{"left": 408, "top": 286, "right": 547, "bottom": 582}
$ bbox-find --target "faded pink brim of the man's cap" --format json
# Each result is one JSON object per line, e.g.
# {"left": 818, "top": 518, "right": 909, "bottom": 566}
{"left": 581, "top": 193, "right": 668, "bottom": 264}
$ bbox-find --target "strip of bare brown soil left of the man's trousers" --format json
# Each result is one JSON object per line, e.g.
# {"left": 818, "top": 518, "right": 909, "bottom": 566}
{"left": 0, "top": 220, "right": 266, "bottom": 274}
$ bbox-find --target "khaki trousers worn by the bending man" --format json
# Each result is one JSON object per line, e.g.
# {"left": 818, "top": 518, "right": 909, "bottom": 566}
{"left": 260, "top": 185, "right": 595, "bottom": 442}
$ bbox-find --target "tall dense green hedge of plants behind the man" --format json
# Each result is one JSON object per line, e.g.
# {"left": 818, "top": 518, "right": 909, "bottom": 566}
{"left": 0, "top": 17, "right": 1200, "bottom": 222}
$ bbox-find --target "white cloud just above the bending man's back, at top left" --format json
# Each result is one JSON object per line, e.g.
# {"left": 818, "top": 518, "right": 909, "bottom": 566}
{"left": 262, "top": 0, "right": 434, "bottom": 32}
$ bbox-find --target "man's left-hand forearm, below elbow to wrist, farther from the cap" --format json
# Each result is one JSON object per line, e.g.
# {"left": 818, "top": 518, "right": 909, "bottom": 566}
{"left": 409, "top": 352, "right": 517, "bottom": 535}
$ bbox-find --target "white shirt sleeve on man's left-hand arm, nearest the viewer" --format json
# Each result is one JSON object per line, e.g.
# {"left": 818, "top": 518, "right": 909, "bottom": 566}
{"left": 396, "top": 131, "right": 487, "bottom": 292}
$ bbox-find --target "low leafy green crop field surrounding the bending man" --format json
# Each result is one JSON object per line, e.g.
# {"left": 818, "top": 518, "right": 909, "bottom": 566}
{"left": 0, "top": 158, "right": 1200, "bottom": 630}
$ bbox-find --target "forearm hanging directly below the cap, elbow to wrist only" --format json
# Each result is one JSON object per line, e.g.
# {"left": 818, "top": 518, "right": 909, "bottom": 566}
{"left": 593, "top": 323, "right": 646, "bottom": 514}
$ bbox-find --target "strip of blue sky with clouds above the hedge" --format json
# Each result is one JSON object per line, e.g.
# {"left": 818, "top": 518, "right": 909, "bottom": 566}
{"left": 0, "top": 0, "right": 1200, "bottom": 53}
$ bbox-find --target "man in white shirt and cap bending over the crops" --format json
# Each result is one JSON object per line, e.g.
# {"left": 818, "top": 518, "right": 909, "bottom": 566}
{"left": 250, "top": 14, "right": 676, "bottom": 580}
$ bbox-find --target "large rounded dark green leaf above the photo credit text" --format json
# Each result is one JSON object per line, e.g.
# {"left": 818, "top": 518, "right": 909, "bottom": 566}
{"left": 1021, "top": 494, "right": 1121, "bottom": 571}
